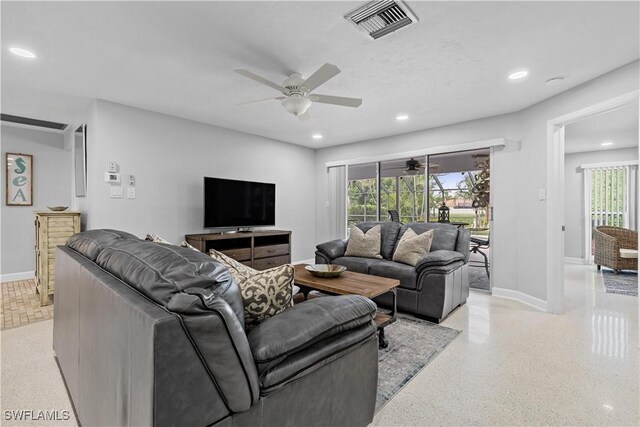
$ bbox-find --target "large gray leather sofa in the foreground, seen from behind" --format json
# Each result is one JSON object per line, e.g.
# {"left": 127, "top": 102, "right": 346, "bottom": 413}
{"left": 53, "top": 230, "right": 378, "bottom": 426}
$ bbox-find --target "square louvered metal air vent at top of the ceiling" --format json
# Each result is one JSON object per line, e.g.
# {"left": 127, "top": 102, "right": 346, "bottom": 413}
{"left": 345, "top": 0, "right": 418, "bottom": 39}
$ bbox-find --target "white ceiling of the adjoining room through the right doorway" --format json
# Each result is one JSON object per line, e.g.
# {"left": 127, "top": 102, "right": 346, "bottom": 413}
{"left": 565, "top": 103, "right": 639, "bottom": 153}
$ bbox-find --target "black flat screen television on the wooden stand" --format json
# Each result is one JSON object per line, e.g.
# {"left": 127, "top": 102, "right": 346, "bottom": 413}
{"left": 204, "top": 177, "right": 276, "bottom": 228}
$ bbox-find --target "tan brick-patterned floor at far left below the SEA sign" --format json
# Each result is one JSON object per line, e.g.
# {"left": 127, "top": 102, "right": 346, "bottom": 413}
{"left": 0, "top": 279, "right": 53, "bottom": 329}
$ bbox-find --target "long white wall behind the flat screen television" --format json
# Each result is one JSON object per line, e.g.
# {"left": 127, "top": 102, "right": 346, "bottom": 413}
{"left": 76, "top": 101, "right": 315, "bottom": 261}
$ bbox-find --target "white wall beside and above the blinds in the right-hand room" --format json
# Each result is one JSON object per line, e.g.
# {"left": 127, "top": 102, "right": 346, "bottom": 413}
{"left": 564, "top": 147, "right": 638, "bottom": 258}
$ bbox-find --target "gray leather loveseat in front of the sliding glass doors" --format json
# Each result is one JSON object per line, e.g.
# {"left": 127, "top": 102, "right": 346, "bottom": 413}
{"left": 316, "top": 221, "right": 470, "bottom": 323}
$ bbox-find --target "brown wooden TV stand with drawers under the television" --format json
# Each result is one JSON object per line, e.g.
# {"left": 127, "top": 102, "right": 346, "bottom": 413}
{"left": 184, "top": 230, "right": 291, "bottom": 270}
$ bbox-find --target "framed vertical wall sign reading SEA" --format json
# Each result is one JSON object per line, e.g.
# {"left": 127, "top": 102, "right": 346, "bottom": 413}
{"left": 5, "top": 153, "right": 33, "bottom": 206}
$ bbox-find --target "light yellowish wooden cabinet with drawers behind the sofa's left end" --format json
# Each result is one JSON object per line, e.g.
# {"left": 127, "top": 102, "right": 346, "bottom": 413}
{"left": 35, "top": 211, "right": 80, "bottom": 306}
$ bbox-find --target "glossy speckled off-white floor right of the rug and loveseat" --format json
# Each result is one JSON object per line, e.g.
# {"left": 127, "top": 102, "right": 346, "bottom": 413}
{"left": 374, "top": 265, "right": 640, "bottom": 426}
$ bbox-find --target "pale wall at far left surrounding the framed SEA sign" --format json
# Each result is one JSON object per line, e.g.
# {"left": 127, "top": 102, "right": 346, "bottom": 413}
{"left": 0, "top": 125, "right": 73, "bottom": 280}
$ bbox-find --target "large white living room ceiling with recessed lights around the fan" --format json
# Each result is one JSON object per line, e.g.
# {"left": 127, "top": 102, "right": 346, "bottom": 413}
{"left": 0, "top": 1, "right": 640, "bottom": 147}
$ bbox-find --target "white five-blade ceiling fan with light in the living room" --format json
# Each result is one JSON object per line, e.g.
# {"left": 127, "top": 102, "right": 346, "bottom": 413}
{"left": 233, "top": 64, "right": 362, "bottom": 120}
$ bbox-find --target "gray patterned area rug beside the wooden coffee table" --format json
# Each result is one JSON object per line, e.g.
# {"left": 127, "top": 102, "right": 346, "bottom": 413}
{"left": 376, "top": 314, "right": 460, "bottom": 412}
